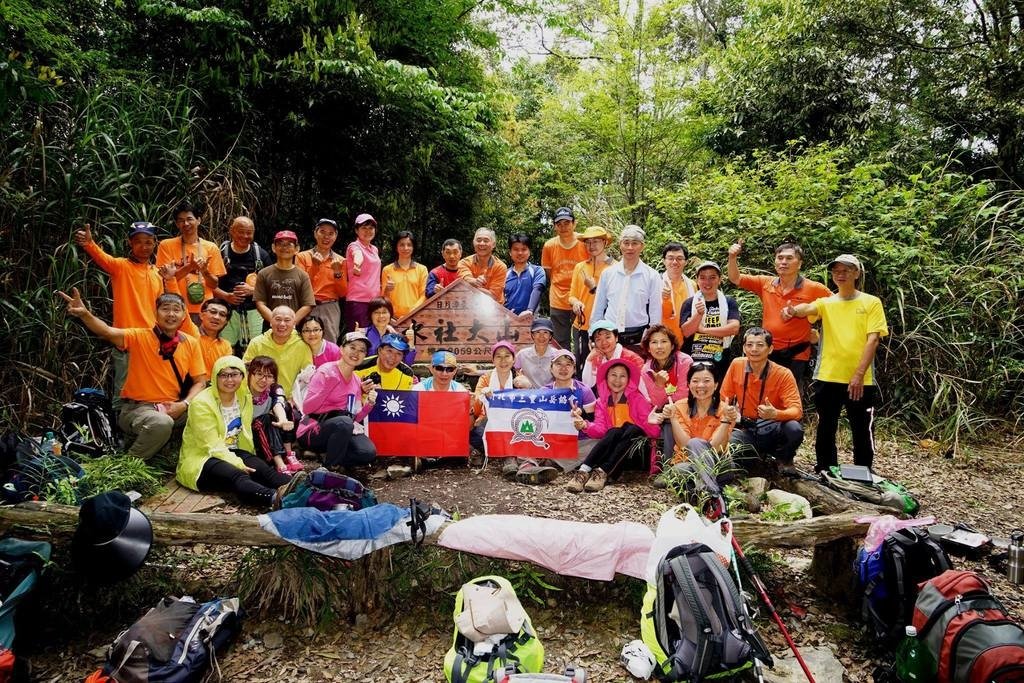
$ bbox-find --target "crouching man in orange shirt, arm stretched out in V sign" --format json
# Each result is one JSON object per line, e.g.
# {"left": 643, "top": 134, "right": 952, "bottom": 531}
{"left": 57, "top": 289, "right": 209, "bottom": 460}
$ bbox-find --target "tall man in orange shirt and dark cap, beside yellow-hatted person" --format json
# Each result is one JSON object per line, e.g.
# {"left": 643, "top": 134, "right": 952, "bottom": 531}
{"left": 541, "top": 207, "right": 596, "bottom": 356}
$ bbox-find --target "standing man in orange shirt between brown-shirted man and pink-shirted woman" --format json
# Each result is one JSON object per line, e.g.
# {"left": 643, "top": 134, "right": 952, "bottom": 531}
{"left": 295, "top": 218, "right": 347, "bottom": 344}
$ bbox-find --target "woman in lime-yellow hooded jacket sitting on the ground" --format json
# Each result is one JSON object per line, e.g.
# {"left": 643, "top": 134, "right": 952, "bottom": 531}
{"left": 175, "top": 355, "right": 306, "bottom": 509}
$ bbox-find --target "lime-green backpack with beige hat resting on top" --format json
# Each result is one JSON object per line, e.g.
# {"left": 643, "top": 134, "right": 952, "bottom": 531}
{"left": 444, "top": 577, "right": 544, "bottom": 683}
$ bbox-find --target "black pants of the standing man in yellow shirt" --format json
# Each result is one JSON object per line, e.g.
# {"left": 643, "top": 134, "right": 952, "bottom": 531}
{"left": 814, "top": 382, "right": 879, "bottom": 472}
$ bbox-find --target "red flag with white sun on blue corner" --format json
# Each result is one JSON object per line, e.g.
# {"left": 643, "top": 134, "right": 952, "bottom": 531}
{"left": 367, "top": 390, "right": 470, "bottom": 458}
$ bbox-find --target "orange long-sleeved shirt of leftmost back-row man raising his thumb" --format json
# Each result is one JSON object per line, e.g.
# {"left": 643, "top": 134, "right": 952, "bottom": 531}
{"left": 85, "top": 242, "right": 164, "bottom": 330}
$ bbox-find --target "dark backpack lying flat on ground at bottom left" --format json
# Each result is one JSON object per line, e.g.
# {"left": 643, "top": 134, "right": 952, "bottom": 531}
{"left": 86, "top": 597, "right": 242, "bottom": 683}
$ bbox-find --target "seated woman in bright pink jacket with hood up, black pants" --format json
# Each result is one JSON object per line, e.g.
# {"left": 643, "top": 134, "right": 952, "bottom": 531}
{"left": 565, "top": 358, "right": 658, "bottom": 494}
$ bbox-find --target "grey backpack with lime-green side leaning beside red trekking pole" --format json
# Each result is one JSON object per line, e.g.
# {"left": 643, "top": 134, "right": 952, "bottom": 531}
{"left": 640, "top": 544, "right": 772, "bottom": 683}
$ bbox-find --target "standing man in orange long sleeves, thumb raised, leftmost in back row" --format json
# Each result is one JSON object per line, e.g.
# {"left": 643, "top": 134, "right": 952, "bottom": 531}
{"left": 75, "top": 221, "right": 177, "bottom": 411}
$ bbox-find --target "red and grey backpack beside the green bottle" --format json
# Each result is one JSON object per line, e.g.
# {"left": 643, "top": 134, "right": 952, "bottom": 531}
{"left": 913, "top": 569, "right": 1024, "bottom": 683}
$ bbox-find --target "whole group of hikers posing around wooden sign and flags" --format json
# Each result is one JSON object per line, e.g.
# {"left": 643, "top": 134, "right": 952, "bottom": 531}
{"left": 60, "top": 206, "right": 888, "bottom": 508}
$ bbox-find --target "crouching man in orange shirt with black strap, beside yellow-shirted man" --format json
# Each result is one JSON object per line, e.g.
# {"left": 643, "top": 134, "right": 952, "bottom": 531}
{"left": 721, "top": 328, "right": 804, "bottom": 470}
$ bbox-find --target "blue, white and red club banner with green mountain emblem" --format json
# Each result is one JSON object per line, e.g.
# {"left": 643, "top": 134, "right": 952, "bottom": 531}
{"left": 483, "top": 389, "right": 578, "bottom": 460}
